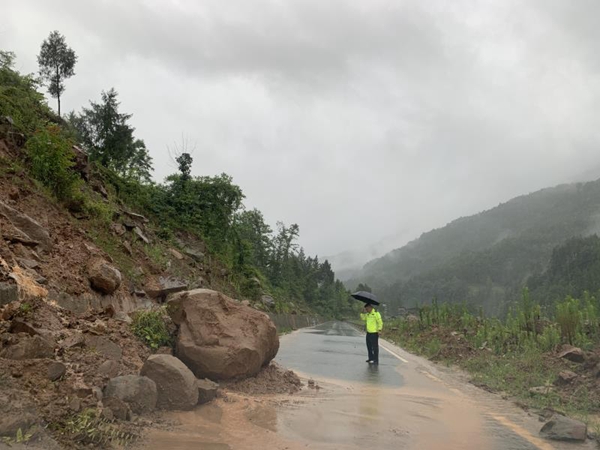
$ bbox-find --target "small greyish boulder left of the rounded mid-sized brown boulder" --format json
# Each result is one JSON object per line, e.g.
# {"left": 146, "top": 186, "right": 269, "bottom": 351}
{"left": 104, "top": 375, "right": 158, "bottom": 414}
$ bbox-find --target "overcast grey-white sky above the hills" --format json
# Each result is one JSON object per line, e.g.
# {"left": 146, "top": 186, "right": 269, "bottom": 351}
{"left": 0, "top": 0, "right": 600, "bottom": 268}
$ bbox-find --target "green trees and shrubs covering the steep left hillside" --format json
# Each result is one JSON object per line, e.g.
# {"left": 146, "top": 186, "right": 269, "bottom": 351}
{"left": 0, "top": 44, "right": 357, "bottom": 317}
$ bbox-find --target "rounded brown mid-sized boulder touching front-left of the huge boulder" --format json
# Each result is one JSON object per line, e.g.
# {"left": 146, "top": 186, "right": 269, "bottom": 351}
{"left": 140, "top": 355, "right": 198, "bottom": 410}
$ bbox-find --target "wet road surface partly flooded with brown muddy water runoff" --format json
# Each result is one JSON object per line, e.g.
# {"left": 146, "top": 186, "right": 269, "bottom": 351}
{"left": 140, "top": 322, "right": 596, "bottom": 450}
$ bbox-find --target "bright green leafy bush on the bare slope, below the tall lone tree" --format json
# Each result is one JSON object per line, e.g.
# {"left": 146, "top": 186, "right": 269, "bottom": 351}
{"left": 27, "top": 125, "right": 81, "bottom": 200}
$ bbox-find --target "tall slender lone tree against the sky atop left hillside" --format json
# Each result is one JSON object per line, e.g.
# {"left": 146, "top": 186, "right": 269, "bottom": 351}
{"left": 38, "top": 31, "right": 77, "bottom": 117}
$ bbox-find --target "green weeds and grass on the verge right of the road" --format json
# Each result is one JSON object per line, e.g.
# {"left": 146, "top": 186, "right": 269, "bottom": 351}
{"left": 384, "top": 290, "right": 600, "bottom": 419}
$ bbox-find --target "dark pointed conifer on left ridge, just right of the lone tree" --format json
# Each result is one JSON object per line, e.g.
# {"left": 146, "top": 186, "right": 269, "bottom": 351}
{"left": 69, "top": 89, "right": 152, "bottom": 181}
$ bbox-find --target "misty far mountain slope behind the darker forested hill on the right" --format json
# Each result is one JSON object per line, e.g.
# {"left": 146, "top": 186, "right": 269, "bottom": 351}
{"left": 347, "top": 180, "right": 600, "bottom": 314}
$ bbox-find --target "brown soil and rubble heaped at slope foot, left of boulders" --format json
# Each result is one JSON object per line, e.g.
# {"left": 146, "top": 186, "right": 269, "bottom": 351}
{"left": 0, "top": 299, "right": 150, "bottom": 446}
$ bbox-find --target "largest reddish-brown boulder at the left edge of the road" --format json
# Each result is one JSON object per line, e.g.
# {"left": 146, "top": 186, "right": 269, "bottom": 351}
{"left": 168, "top": 289, "right": 279, "bottom": 380}
